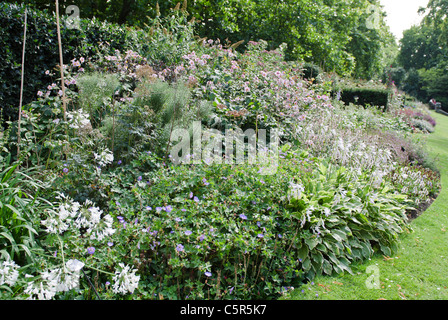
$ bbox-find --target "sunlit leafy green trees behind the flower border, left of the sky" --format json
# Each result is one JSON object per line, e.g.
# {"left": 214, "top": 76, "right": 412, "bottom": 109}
{"left": 4, "top": 0, "right": 394, "bottom": 79}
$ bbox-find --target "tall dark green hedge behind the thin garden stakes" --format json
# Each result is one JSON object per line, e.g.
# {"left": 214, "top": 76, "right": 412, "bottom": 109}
{"left": 0, "top": 3, "right": 145, "bottom": 124}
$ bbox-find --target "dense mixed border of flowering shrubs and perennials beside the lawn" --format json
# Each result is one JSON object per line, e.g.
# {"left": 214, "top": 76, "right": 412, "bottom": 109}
{"left": 0, "top": 4, "right": 439, "bottom": 299}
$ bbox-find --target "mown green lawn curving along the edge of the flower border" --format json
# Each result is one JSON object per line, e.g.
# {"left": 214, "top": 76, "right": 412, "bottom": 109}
{"left": 280, "top": 112, "right": 448, "bottom": 300}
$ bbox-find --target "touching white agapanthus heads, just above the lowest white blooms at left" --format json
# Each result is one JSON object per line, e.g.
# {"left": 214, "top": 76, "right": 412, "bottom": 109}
{"left": 41, "top": 194, "right": 115, "bottom": 241}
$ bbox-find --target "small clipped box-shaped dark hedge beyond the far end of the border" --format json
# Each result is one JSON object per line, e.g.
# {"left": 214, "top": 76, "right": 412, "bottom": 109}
{"left": 341, "top": 88, "right": 390, "bottom": 110}
